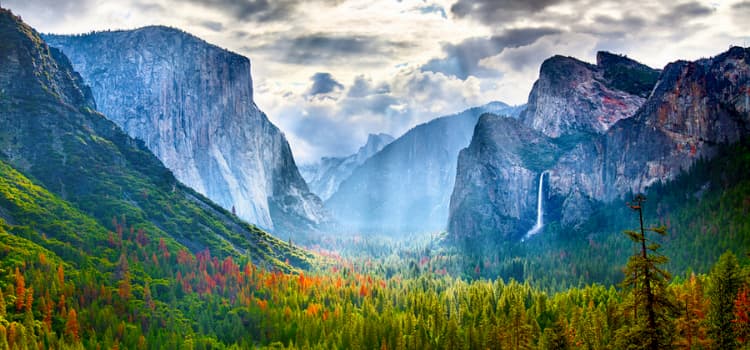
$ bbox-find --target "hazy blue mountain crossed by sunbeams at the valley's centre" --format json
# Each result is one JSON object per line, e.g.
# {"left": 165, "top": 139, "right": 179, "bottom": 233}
{"left": 326, "top": 102, "right": 523, "bottom": 233}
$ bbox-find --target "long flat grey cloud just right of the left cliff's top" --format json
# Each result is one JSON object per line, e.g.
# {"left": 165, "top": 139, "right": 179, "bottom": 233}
{"left": 247, "top": 34, "right": 410, "bottom": 64}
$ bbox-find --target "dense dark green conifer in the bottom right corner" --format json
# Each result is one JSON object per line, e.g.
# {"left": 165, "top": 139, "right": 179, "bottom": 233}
{"left": 708, "top": 252, "right": 742, "bottom": 349}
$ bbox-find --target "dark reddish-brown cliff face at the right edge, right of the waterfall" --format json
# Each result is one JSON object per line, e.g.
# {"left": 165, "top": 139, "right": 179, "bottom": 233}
{"left": 601, "top": 47, "right": 750, "bottom": 200}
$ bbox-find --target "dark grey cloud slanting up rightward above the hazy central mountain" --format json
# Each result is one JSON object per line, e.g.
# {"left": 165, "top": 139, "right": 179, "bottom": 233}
{"left": 421, "top": 28, "right": 561, "bottom": 80}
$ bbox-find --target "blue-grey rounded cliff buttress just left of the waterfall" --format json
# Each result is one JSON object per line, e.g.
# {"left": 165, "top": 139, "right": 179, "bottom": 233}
{"left": 448, "top": 114, "right": 558, "bottom": 239}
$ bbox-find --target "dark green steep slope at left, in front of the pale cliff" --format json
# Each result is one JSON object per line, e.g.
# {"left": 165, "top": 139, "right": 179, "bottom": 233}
{"left": 0, "top": 9, "right": 312, "bottom": 269}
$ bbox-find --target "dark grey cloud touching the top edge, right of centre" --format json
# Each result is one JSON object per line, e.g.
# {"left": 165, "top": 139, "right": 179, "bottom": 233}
{"left": 451, "top": 0, "right": 562, "bottom": 25}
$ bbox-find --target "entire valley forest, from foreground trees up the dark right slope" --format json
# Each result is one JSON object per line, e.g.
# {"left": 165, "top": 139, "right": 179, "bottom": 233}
{"left": 0, "top": 137, "right": 750, "bottom": 349}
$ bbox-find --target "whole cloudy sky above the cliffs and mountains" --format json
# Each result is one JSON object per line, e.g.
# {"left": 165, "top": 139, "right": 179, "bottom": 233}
{"left": 5, "top": 0, "right": 750, "bottom": 164}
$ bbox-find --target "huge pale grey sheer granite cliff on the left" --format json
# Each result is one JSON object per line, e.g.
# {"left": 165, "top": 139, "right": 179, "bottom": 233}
{"left": 46, "top": 27, "right": 328, "bottom": 233}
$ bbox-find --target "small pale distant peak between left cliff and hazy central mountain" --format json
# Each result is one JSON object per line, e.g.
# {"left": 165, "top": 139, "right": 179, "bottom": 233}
{"left": 299, "top": 134, "right": 393, "bottom": 201}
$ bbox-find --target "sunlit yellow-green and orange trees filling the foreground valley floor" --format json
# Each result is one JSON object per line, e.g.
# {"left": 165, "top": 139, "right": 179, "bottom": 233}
{"left": 0, "top": 219, "right": 750, "bottom": 349}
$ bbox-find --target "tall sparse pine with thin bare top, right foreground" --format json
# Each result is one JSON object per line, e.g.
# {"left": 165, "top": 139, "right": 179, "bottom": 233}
{"left": 617, "top": 194, "right": 675, "bottom": 350}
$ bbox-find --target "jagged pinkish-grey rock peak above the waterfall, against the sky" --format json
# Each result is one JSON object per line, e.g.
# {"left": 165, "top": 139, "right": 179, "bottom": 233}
{"left": 521, "top": 52, "right": 659, "bottom": 137}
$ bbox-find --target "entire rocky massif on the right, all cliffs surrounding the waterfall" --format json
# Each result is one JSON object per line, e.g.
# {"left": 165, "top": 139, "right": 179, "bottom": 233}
{"left": 449, "top": 47, "right": 750, "bottom": 241}
